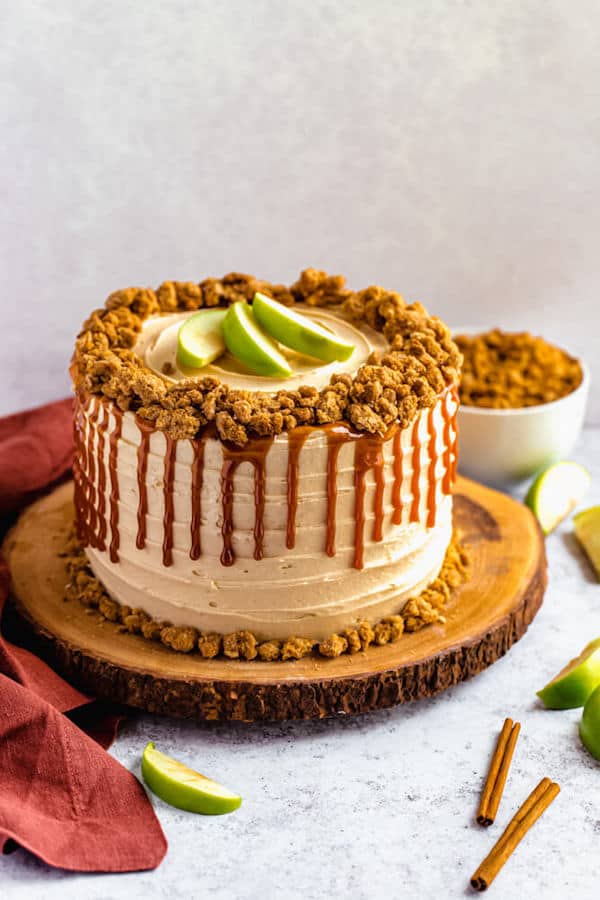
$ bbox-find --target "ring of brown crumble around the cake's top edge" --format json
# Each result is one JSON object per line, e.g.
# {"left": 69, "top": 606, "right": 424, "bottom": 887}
{"left": 71, "top": 269, "right": 462, "bottom": 445}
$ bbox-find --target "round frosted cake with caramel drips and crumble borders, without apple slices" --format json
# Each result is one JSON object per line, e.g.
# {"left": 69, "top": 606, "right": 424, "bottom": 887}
{"left": 68, "top": 269, "right": 465, "bottom": 661}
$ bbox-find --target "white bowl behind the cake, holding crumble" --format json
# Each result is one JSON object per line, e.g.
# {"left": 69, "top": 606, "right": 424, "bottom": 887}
{"left": 453, "top": 327, "right": 590, "bottom": 488}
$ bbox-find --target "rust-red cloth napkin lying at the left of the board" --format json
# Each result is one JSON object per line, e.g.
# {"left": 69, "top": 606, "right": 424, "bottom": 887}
{"left": 0, "top": 400, "right": 167, "bottom": 872}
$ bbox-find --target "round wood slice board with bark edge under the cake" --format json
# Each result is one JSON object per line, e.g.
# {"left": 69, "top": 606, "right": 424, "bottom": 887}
{"left": 4, "top": 478, "right": 546, "bottom": 722}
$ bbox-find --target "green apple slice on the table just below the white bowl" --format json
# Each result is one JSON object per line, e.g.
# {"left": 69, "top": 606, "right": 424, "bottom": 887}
{"left": 525, "top": 461, "right": 592, "bottom": 534}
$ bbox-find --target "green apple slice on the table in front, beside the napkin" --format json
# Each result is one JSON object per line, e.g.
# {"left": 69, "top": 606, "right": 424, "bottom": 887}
{"left": 142, "top": 741, "right": 242, "bottom": 816}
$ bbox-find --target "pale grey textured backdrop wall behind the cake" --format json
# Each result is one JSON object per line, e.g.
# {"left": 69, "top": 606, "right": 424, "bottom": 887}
{"left": 0, "top": 0, "right": 600, "bottom": 423}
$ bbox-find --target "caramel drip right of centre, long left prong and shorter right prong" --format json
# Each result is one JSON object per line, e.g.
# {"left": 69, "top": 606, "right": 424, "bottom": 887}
{"left": 354, "top": 434, "right": 385, "bottom": 569}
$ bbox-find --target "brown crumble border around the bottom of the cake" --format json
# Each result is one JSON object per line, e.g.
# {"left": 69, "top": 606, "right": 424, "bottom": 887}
{"left": 61, "top": 529, "right": 469, "bottom": 662}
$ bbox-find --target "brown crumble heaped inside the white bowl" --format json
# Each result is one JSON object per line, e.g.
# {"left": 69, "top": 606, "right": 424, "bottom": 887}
{"left": 455, "top": 328, "right": 583, "bottom": 409}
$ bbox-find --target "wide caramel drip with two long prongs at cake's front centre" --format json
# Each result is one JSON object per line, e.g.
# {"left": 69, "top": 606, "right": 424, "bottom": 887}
{"left": 221, "top": 437, "right": 273, "bottom": 566}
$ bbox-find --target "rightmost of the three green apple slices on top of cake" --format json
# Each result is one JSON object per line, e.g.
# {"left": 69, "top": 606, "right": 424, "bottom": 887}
{"left": 252, "top": 293, "right": 354, "bottom": 362}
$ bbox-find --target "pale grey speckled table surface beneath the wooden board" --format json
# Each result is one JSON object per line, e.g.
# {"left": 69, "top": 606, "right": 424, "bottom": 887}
{"left": 0, "top": 429, "right": 600, "bottom": 900}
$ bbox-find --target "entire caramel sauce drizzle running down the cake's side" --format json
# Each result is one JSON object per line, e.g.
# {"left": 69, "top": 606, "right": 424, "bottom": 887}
{"left": 73, "top": 386, "right": 458, "bottom": 569}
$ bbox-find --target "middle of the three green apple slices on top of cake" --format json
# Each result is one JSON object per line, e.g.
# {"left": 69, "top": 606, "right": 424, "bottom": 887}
{"left": 223, "top": 300, "right": 292, "bottom": 378}
